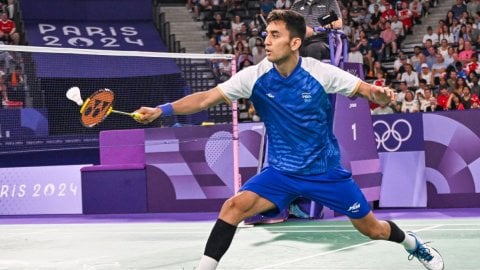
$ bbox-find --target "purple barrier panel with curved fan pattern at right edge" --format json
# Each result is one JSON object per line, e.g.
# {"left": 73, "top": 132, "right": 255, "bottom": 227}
{"left": 423, "top": 110, "right": 480, "bottom": 207}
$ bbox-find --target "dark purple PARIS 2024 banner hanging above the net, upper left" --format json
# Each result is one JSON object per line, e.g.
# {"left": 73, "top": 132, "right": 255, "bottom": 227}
{"left": 22, "top": 0, "right": 180, "bottom": 78}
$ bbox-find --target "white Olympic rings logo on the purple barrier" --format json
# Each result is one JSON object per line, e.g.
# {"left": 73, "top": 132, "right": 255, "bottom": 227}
{"left": 373, "top": 119, "right": 413, "bottom": 152}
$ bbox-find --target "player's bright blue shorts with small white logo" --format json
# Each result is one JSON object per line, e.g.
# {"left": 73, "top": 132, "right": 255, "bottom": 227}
{"left": 240, "top": 167, "right": 371, "bottom": 218}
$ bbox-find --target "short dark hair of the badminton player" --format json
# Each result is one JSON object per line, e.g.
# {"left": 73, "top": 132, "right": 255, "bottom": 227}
{"left": 267, "top": 9, "right": 307, "bottom": 40}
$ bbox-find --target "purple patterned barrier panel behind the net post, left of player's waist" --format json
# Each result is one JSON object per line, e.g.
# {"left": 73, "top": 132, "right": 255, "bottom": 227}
{"left": 145, "top": 123, "right": 263, "bottom": 212}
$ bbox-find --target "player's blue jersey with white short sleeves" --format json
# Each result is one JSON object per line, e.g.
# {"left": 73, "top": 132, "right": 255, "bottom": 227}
{"left": 219, "top": 57, "right": 361, "bottom": 175}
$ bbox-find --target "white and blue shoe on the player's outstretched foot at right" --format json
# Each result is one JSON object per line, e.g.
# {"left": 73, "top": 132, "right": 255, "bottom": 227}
{"left": 407, "top": 232, "right": 443, "bottom": 270}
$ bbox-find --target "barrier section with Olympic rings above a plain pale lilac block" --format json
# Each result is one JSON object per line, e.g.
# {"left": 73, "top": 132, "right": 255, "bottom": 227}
{"left": 372, "top": 113, "right": 427, "bottom": 207}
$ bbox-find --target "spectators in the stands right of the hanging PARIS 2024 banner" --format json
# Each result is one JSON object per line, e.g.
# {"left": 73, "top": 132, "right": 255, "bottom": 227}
{"left": 189, "top": 0, "right": 480, "bottom": 119}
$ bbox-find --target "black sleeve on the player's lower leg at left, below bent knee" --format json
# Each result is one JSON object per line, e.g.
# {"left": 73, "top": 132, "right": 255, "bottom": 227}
{"left": 204, "top": 219, "right": 237, "bottom": 261}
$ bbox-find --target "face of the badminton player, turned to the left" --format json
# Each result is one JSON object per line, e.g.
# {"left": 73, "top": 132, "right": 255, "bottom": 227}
{"left": 265, "top": 21, "right": 301, "bottom": 64}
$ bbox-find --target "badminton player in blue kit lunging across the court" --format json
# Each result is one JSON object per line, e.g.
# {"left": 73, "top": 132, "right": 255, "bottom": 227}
{"left": 136, "top": 10, "right": 443, "bottom": 270}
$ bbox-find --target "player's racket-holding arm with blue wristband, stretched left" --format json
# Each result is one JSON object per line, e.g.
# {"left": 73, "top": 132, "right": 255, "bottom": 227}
{"left": 134, "top": 87, "right": 226, "bottom": 124}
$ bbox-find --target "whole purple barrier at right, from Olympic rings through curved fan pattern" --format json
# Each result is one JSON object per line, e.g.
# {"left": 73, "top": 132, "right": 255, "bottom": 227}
{"left": 373, "top": 110, "right": 480, "bottom": 207}
